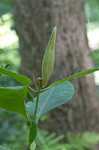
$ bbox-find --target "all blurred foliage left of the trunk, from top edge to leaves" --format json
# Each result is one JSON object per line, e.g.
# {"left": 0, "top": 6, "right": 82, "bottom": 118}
{"left": 0, "top": 0, "right": 20, "bottom": 86}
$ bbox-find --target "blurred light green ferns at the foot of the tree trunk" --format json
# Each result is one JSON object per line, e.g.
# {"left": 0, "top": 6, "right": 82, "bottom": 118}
{"left": 37, "top": 130, "right": 99, "bottom": 150}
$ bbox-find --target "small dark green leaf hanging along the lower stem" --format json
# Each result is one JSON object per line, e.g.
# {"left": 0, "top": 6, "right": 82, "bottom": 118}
{"left": 29, "top": 120, "right": 37, "bottom": 145}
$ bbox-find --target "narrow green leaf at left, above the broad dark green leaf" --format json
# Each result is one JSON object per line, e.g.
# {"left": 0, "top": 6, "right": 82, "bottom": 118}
{"left": 0, "top": 68, "right": 31, "bottom": 86}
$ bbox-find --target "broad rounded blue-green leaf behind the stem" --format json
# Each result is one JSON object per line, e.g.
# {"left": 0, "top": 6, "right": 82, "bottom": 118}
{"left": 26, "top": 81, "right": 74, "bottom": 118}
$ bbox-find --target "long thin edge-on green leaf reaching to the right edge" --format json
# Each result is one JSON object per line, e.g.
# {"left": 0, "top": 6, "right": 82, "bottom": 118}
{"left": 46, "top": 67, "right": 99, "bottom": 89}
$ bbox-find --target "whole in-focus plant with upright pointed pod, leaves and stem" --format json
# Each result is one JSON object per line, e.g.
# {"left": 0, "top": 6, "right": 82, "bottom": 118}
{"left": 0, "top": 27, "right": 99, "bottom": 150}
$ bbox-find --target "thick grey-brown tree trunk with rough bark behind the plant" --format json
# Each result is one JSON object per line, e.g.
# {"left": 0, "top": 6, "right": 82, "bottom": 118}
{"left": 14, "top": 0, "right": 99, "bottom": 134}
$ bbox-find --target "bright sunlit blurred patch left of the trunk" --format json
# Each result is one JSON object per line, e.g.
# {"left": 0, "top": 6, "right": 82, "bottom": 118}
{"left": 0, "top": 14, "right": 20, "bottom": 71}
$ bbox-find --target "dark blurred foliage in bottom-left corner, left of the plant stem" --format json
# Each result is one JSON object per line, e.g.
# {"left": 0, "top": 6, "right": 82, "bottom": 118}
{"left": 0, "top": 111, "right": 28, "bottom": 150}
